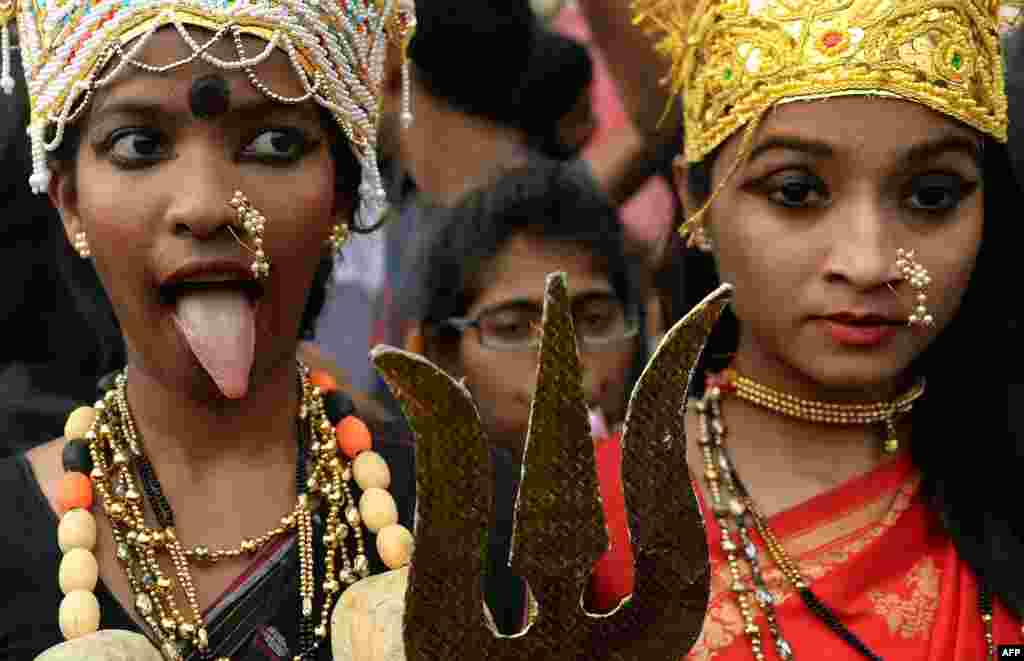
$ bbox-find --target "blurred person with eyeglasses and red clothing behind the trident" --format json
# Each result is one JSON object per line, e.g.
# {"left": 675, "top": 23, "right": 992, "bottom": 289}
{"left": 402, "top": 159, "right": 646, "bottom": 630}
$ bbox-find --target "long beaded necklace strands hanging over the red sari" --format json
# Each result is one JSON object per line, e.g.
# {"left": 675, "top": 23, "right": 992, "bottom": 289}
{"left": 694, "top": 373, "right": 1003, "bottom": 661}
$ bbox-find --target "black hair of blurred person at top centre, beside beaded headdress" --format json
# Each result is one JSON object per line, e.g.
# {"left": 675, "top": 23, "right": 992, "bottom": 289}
{"left": 409, "top": 0, "right": 536, "bottom": 126}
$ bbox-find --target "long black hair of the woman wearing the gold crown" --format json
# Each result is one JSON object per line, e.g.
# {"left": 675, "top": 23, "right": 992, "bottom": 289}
{"left": 686, "top": 137, "right": 1024, "bottom": 615}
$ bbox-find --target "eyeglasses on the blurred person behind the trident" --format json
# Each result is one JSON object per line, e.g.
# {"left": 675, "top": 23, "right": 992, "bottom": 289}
{"left": 441, "top": 293, "right": 640, "bottom": 351}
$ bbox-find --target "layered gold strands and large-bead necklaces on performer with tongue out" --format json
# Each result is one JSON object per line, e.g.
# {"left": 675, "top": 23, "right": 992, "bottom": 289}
{"left": 57, "top": 364, "right": 412, "bottom": 661}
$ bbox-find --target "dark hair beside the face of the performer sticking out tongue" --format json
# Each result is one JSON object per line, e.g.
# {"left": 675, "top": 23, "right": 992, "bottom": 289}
{"left": 47, "top": 100, "right": 361, "bottom": 378}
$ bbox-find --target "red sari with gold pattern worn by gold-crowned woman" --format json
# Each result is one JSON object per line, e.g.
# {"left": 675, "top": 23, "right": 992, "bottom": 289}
{"left": 686, "top": 453, "right": 1024, "bottom": 661}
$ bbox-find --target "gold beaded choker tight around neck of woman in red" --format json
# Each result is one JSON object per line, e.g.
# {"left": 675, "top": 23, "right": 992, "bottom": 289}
{"left": 709, "top": 369, "right": 925, "bottom": 454}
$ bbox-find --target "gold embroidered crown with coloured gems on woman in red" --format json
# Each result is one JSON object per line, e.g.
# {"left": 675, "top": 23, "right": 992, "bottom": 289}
{"left": 634, "top": 0, "right": 1021, "bottom": 163}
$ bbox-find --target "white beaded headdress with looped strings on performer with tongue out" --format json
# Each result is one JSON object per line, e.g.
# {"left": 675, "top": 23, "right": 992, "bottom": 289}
{"left": 0, "top": 0, "right": 416, "bottom": 224}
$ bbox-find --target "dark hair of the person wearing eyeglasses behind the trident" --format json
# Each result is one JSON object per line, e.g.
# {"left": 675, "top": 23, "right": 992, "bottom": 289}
{"left": 400, "top": 159, "right": 642, "bottom": 360}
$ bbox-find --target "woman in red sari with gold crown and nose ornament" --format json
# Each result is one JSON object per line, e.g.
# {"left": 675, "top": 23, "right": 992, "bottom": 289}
{"left": 626, "top": 0, "right": 1024, "bottom": 661}
